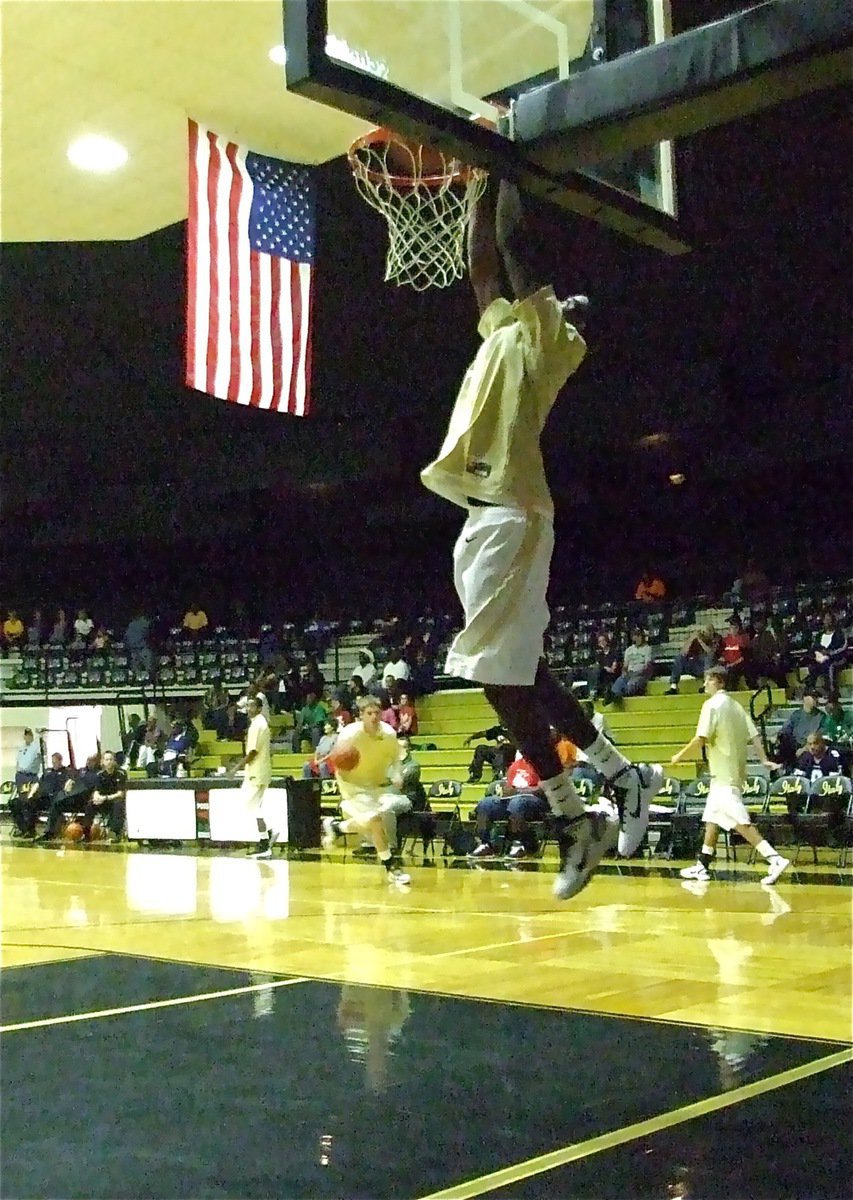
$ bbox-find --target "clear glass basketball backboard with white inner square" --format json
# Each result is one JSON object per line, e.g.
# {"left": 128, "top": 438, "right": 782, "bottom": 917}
{"left": 286, "top": 0, "right": 685, "bottom": 248}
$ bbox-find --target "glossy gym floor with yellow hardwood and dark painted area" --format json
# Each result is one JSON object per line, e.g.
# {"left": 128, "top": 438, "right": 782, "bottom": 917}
{"left": 0, "top": 844, "right": 852, "bottom": 1200}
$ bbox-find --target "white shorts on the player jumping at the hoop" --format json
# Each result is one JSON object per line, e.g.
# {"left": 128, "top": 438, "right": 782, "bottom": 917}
{"left": 445, "top": 505, "right": 554, "bottom": 685}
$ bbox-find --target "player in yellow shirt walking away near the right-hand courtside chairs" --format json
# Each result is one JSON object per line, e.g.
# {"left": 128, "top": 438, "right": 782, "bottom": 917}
{"left": 672, "top": 666, "right": 791, "bottom": 883}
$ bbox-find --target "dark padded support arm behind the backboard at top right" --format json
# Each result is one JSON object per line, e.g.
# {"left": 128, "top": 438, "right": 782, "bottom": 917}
{"left": 512, "top": 0, "right": 853, "bottom": 172}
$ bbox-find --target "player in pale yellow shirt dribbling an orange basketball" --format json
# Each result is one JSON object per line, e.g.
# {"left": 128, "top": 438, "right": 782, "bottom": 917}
{"left": 323, "top": 696, "right": 410, "bottom": 884}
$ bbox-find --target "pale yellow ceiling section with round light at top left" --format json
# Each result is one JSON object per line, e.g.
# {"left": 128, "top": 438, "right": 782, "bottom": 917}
{"left": 0, "top": 0, "right": 367, "bottom": 241}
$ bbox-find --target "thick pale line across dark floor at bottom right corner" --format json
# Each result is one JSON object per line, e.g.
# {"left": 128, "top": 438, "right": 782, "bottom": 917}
{"left": 420, "top": 1049, "right": 853, "bottom": 1200}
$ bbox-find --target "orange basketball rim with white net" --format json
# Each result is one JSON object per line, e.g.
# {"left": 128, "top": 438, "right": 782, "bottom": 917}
{"left": 348, "top": 128, "right": 488, "bottom": 292}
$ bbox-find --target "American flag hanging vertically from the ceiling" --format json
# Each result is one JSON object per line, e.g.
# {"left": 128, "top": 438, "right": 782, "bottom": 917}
{"left": 186, "top": 121, "right": 314, "bottom": 416}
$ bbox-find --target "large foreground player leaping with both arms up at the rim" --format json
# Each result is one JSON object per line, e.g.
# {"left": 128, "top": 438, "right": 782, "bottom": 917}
{"left": 421, "top": 180, "right": 663, "bottom": 899}
